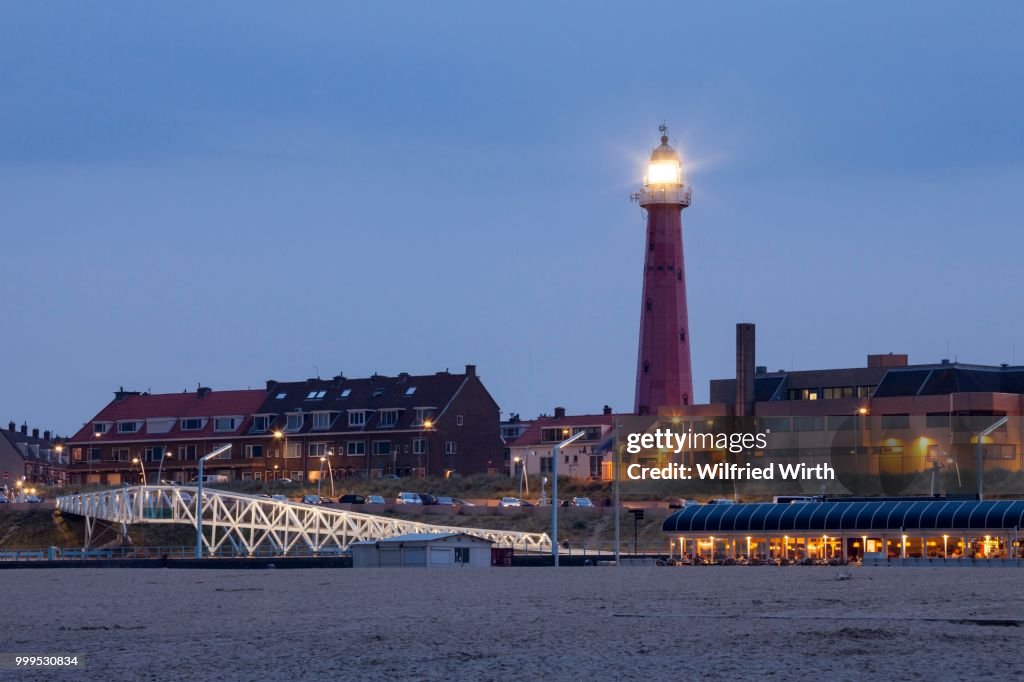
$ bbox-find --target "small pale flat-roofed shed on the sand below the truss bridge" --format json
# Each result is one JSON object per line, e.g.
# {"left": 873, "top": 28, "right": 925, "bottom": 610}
{"left": 351, "top": 532, "right": 492, "bottom": 568}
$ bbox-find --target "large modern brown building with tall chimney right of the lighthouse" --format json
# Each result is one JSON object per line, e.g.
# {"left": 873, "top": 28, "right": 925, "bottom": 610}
{"left": 634, "top": 325, "right": 1024, "bottom": 495}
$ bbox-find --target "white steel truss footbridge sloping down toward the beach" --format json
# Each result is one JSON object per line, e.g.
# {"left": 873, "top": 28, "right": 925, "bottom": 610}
{"left": 57, "top": 485, "right": 551, "bottom": 555}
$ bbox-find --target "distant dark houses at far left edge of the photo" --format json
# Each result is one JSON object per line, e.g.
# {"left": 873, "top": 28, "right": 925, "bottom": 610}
{"left": 0, "top": 422, "right": 69, "bottom": 489}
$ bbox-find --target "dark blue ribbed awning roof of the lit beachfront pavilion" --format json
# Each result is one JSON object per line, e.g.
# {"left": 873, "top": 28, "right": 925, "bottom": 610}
{"left": 662, "top": 500, "right": 1024, "bottom": 535}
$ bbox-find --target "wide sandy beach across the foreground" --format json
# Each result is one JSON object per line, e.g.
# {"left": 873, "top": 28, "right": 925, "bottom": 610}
{"left": 0, "top": 567, "right": 1024, "bottom": 680}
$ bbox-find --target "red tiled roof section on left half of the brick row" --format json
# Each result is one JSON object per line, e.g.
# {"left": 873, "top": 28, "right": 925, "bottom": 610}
{"left": 71, "top": 389, "right": 266, "bottom": 442}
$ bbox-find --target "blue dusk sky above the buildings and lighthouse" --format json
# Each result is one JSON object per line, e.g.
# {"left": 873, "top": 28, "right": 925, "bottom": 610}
{"left": 0, "top": 2, "right": 1024, "bottom": 433}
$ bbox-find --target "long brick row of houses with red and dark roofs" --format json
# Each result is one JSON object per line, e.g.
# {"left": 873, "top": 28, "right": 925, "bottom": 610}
{"left": 67, "top": 365, "right": 503, "bottom": 484}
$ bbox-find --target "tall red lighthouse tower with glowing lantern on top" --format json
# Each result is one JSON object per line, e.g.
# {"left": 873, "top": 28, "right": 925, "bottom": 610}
{"left": 632, "top": 125, "right": 693, "bottom": 415}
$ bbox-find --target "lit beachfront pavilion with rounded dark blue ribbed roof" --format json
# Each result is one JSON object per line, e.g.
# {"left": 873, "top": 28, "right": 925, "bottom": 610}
{"left": 662, "top": 499, "right": 1024, "bottom": 562}
